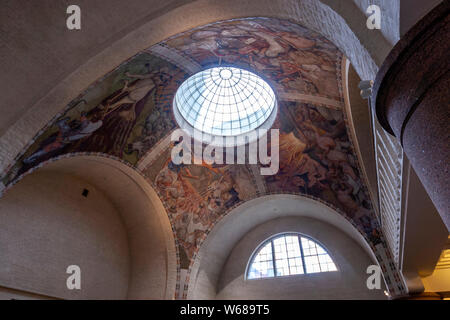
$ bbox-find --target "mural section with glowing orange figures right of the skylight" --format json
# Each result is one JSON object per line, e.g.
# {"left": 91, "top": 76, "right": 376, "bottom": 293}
{"left": 265, "top": 103, "right": 377, "bottom": 242}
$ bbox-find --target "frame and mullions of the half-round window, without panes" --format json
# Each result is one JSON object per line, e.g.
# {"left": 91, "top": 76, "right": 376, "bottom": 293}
{"left": 244, "top": 231, "right": 340, "bottom": 281}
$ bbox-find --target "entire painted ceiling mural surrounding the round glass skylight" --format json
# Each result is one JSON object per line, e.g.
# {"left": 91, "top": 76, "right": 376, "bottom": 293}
{"left": 1, "top": 18, "right": 404, "bottom": 293}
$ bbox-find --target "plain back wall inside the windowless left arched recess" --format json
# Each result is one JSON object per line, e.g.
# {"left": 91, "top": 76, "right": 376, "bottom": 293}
{"left": 0, "top": 172, "right": 130, "bottom": 299}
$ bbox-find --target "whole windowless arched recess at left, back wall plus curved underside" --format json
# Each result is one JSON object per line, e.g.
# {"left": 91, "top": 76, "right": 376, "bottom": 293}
{"left": 0, "top": 156, "right": 176, "bottom": 299}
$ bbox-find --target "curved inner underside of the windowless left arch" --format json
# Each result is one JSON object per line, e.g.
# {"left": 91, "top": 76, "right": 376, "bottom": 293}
{"left": 32, "top": 156, "right": 176, "bottom": 299}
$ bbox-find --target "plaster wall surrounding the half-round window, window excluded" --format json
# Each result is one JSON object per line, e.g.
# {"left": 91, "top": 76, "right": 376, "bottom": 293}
{"left": 216, "top": 216, "right": 387, "bottom": 300}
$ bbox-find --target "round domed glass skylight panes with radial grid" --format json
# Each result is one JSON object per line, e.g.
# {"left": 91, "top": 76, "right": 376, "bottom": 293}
{"left": 175, "top": 67, "right": 276, "bottom": 136}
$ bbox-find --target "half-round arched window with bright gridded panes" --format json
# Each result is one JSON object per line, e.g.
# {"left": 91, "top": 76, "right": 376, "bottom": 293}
{"left": 247, "top": 233, "right": 337, "bottom": 279}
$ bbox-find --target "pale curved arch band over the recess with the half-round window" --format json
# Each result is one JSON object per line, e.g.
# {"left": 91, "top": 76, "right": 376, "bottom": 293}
{"left": 186, "top": 194, "right": 404, "bottom": 299}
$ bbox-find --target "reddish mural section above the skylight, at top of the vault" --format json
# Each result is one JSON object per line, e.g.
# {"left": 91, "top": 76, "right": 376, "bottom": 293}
{"left": 166, "top": 19, "right": 340, "bottom": 98}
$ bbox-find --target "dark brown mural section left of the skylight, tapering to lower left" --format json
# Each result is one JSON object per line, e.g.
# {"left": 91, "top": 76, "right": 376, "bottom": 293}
{"left": 4, "top": 54, "right": 180, "bottom": 181}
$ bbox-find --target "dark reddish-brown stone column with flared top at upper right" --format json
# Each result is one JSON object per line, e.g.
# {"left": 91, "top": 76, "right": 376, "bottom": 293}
{"left": 372, "top": 0, "right": 450, "bottom": 230}
